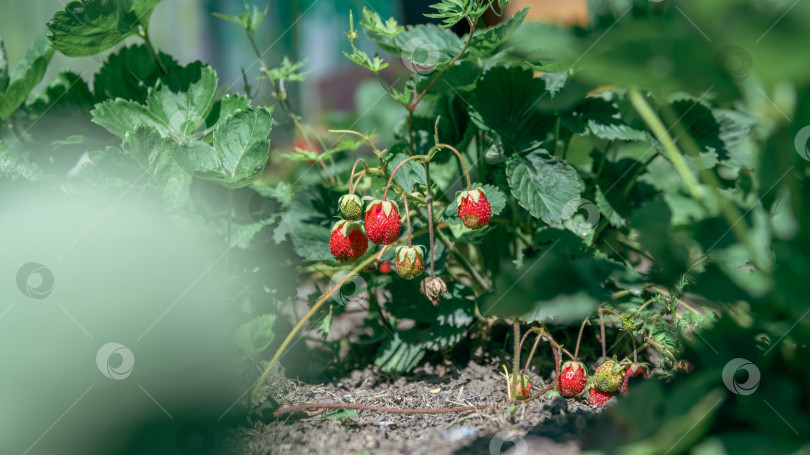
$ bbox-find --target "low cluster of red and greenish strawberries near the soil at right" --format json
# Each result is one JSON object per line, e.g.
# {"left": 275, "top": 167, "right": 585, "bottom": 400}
{"left": 557, "top": 360, "right": 649, "bottom": 408}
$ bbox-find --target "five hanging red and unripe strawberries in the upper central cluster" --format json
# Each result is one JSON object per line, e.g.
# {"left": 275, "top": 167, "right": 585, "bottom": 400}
{"left": 329, "top": 188, "right": 492, "bottom": 280}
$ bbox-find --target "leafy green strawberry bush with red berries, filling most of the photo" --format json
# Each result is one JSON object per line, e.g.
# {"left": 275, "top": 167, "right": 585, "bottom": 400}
{"left": 0, "top": 0, "right": 810, "bottom": 453}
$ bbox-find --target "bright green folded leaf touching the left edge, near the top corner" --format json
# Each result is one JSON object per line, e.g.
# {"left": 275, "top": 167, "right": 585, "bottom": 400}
{"left": 0, "top": 33, "right": 53, "bottom": 118}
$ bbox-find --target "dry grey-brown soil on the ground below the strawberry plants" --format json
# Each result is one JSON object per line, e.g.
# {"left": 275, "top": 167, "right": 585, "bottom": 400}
{"left": 231, "top": 361, "right": 608, "bottom": 455}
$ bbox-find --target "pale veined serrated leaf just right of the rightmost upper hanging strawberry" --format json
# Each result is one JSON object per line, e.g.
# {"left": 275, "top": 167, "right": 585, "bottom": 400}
{"left": 506, "top": 151, "right": 585, "bottom": 224}
